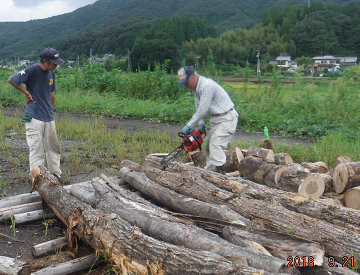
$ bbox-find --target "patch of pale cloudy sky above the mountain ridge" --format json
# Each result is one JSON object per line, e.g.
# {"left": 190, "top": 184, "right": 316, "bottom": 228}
{"left": 0, "top": 0, "right": 96, "bottom": 22}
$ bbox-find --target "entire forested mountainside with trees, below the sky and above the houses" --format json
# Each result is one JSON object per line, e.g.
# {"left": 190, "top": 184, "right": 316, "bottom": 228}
{"left": 0, "top": 0, "right": 360, "bottom": 70}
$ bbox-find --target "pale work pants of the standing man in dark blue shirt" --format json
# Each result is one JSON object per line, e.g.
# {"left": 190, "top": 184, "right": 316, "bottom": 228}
{"left": 25, "top": 118, "right": 61, "bottom": 176}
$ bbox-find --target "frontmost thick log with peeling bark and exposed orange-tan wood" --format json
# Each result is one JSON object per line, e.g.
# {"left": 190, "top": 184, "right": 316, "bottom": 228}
{"left": 30, "top": 166, "right": 253, "bottom": 274}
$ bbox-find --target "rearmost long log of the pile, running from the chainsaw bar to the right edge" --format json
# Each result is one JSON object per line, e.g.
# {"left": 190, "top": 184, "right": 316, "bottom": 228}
{"left": 131, "top": 156, "right": 360, "bottom": 231}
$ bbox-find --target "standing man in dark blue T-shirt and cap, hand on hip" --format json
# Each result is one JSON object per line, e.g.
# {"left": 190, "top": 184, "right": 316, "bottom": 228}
{"left": 8, "top": 48, "right": 64, "bottom": 179}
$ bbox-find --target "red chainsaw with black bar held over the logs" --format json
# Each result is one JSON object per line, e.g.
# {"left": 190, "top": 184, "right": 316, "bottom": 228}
{"left": 160, "top": 130, "right": 206, "bottom": 165}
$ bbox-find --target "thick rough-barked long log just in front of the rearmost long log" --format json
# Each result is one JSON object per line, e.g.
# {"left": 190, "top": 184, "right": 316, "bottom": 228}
{"left": 133, "top": 157, "right": 360, "bottom": 261}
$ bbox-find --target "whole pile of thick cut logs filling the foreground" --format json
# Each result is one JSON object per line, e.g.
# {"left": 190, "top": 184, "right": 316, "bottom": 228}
{"left": 0, "top": 147, "right": 360, "bottom": 274}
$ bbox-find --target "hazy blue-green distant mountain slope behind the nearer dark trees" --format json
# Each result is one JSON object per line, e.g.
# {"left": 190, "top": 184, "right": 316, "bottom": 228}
{"left": 0, "top": 0, "right": 360, "bottom": 59}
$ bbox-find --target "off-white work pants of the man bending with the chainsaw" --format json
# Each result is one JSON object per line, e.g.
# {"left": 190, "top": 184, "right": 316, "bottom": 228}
{"left": 205, "top": 110, "right": 239, "bottom": 171}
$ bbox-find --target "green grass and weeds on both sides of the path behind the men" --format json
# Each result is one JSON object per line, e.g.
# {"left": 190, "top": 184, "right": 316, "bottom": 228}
{"left": 0, "top": 62, "right": 360, "bottom": 171}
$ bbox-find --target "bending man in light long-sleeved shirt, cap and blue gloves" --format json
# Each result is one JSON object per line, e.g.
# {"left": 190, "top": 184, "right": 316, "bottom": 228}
{"left": 178, "top": 66, "right": 239, "bottom": 174}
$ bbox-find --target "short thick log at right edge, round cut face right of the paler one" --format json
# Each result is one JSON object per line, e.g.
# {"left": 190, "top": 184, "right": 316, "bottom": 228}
{"left": 333, "top": 162, "right": 360, "bottom": 194}
